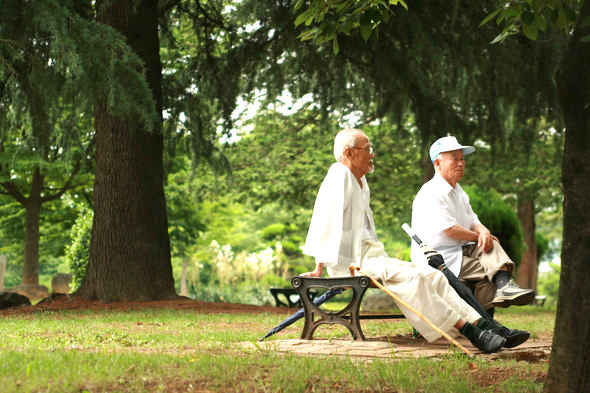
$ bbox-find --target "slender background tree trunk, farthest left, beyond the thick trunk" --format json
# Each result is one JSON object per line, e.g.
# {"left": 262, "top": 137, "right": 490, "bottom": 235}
{"left": 23, "top": 168, "right": 45, "bottom": 285}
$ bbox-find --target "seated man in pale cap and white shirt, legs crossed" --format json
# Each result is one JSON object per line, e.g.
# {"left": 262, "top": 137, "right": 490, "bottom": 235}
{"left": 411, "top": 136, "right": 535, "bottom": 314}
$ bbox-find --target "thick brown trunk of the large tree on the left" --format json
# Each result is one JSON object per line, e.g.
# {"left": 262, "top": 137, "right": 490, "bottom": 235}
{"left": 78, "top": 0, "right": 176, "bottom": 302}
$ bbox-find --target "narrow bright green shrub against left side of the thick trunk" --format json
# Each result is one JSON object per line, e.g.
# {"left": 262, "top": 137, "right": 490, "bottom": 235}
{"left": 65, "top": 207, "right": 94, "bottom": 291}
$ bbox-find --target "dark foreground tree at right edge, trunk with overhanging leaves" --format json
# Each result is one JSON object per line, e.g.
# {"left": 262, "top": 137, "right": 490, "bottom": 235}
{"left": 488, "top": 1, "right": 590, "bottom": 392}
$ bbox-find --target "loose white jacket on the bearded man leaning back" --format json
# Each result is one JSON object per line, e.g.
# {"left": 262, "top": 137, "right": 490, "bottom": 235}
{"left": 303, "top": 162, "right": 377, "bottom": 275}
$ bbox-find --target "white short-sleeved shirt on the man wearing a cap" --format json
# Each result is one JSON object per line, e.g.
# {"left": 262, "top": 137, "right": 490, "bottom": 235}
{"left": 411, "top": 173, "right": 480, "bottom": 276}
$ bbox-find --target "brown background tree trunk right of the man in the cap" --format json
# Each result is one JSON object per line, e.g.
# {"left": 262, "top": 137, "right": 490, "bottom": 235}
{"left": 516, "top": 196, "right": 538, "bottom": 289}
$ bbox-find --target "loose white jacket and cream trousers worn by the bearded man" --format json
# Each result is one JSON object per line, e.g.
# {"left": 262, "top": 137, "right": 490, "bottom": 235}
{"left": 303, "top": 163, "right": 480, "bottom": 342}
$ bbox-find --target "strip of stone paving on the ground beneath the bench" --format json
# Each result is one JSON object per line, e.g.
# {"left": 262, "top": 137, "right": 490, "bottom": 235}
{"left": 240, "top": 336, "right": 551, "bottom": 362}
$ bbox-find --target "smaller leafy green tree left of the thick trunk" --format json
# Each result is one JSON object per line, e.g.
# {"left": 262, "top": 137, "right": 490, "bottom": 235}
{"left": 0, "top": 1, "right": 93, "bottom": 285}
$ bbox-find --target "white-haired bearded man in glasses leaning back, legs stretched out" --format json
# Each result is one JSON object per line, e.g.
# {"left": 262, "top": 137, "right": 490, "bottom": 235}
{"left": 303, "top": 129, "right": 506, "bottom": 352}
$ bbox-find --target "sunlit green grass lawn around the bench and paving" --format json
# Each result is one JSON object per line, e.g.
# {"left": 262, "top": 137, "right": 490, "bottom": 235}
{"left": 0, "top": 306, "right": 555, "bottom": 393}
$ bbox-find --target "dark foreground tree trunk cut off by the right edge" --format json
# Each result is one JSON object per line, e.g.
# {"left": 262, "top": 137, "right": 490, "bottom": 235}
{"left": 544, "top": 1, "right": 590, "bottom": 393}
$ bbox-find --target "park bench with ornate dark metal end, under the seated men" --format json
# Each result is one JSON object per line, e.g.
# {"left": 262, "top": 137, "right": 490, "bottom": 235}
{"left": 291, "top": 276, "right": 405, "bottom": 341}
